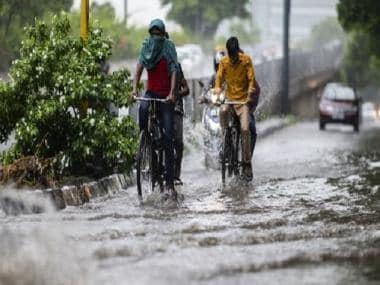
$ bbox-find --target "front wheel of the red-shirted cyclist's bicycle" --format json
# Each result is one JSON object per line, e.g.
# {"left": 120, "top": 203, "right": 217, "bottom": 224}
{"left": 136, "top": 131, "right": 155, "bottom": 198}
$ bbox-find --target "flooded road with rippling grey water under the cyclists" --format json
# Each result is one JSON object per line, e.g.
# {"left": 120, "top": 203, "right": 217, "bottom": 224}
{"left": 0, "top": 122, "right": 380, "bottom": 285}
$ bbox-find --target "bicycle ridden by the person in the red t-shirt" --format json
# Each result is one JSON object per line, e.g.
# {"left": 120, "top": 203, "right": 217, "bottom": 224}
{"left": 136, "top": 97, "right": 167, "bottom": 200}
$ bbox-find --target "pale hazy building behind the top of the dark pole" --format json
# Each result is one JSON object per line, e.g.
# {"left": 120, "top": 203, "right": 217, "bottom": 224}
{"left": 252, "top": 0, "right": 338, "bottom": 42}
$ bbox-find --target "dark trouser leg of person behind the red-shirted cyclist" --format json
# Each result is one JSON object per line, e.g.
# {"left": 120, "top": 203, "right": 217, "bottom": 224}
{"left": 174, "top": 112, "right": 183, "bottom": 179}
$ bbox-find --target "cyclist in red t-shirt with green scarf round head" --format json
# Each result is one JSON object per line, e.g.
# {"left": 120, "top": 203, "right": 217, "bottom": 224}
{"left": 132, "top": 19, "right": 178, "bottom": 197}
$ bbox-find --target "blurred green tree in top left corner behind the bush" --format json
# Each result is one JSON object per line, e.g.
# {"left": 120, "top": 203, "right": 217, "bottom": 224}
{"left": 0, "top": 0, "right": 73, "bottom": 69}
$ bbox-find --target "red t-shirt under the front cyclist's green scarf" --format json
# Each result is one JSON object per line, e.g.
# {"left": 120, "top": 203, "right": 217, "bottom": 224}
{"left": 148, "top": 57, "right": 170, "bottom": 98}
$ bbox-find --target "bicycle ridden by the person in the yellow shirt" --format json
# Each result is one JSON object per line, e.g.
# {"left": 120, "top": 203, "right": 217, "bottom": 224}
{"left": 220, "top": 101, "right": 246, "bottom": 186}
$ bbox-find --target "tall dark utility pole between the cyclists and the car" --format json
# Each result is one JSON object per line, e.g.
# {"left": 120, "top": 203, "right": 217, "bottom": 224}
{"left": 281, "top": 0, "right": 291, "bottom": 115}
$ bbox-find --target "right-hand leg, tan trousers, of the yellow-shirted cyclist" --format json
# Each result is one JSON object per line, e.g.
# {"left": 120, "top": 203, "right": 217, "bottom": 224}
{"left": 235, "top": 105, "right": 252, "bottom": 178}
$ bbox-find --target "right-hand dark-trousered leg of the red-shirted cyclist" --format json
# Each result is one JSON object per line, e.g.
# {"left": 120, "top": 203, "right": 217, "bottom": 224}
{"left": 159, "top": 103, "right": 174, "bottom": 189}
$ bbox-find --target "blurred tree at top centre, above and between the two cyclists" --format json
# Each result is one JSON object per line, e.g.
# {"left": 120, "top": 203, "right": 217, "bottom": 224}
{"left": 161, "top": 0, "right": 249, "bottom": 37}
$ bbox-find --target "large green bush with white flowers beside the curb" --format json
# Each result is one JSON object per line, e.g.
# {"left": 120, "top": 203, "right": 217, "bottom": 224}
{"left": 0, "top": 14, "right": 137, "bottom": 179}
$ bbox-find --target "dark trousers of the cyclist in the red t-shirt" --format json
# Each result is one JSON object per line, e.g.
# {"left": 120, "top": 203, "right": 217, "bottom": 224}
{"left": 139, "top": 91, "right": 174, "bottom": 186}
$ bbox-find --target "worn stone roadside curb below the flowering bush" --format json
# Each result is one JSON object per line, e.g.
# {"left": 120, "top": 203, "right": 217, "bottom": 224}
{"left": 0, "top": 174, "right": 134, "bottom": 215}
